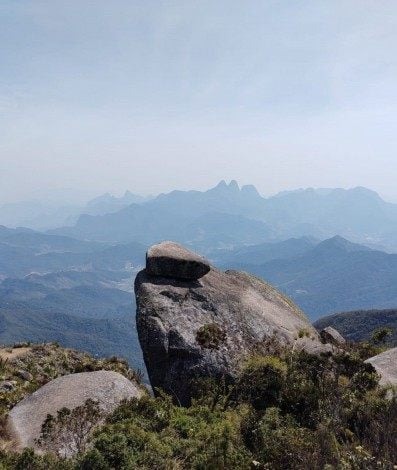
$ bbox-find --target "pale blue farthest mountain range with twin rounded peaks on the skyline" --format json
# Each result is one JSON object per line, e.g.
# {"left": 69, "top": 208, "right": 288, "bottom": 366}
{"left": 51, "top": 181, "right": 397, "bottom": 251}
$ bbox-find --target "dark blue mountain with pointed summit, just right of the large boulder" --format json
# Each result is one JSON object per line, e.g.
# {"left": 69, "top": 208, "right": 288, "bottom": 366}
{"left": 230, "top": 237, "right": 397, "bottom": 319}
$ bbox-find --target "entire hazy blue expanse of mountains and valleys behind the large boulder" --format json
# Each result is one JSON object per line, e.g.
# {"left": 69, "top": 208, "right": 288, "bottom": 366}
{"left": 0, "top": 181, "right": 397, "bottom": 367}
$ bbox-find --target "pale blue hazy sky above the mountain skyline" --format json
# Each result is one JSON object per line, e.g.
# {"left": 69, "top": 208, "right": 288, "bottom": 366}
{"left": 0, "top": 0, "right": 397, "bottom": 203}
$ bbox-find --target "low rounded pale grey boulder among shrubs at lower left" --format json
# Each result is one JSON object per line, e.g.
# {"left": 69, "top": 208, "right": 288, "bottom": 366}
{"left": 7, "top": 370, "right": 142, "bottom": 449}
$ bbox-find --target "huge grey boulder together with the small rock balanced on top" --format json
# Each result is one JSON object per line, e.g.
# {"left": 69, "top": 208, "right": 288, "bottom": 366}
{"left": 135, "top": 243, "right": 327, "bottom": 404}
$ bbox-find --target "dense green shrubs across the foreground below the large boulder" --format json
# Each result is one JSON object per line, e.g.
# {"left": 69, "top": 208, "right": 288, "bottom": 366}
{"left": 0, "top": 348, "right": 397, "bottom": 470}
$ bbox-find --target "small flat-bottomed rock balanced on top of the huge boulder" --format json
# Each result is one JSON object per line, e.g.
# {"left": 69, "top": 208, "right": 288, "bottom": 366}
{"left": 146, "top": 241, "right": 211, "bottom": 279}
